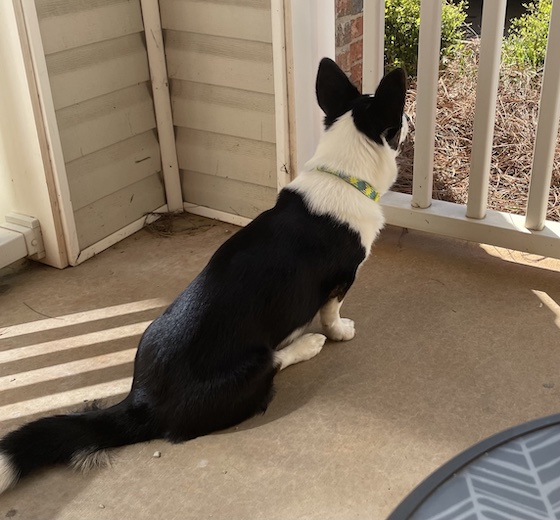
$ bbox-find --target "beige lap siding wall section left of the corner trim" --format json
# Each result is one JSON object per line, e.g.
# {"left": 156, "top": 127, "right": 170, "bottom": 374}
{"left": 35, "top": 0, "right": 165, "bottom": 249}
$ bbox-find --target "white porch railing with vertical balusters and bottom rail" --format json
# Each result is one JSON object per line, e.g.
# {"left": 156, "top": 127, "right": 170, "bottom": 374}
{"left": 363, "top": 0, "right": 560, "bottom": 258}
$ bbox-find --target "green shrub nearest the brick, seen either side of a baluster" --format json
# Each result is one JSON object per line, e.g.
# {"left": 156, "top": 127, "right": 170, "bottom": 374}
{"left": 385, "top": 0, "right": 468, "bottom": 76}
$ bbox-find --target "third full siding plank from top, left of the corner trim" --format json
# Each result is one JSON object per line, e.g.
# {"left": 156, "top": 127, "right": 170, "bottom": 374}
{"left": 56, "top": 83, "right": 156, "bottom": 162}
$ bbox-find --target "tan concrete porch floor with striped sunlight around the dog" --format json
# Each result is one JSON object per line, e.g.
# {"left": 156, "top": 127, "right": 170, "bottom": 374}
{"left": 0, "top": 216, "right": 560, "bottom": 520}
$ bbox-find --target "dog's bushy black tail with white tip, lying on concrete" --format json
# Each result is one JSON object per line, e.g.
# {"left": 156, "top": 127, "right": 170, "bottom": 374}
{"left": 0, "top": 398, "right": 159, "bottom": 493}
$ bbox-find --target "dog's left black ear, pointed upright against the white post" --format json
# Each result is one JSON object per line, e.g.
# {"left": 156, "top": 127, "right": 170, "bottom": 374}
{"left": 315, "top": 58, "right": 360, "bottom": 125}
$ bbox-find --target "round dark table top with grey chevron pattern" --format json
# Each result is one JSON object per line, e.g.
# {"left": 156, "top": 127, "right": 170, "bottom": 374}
{"left": 388, "top": 414, "right": 560, "bottom": 520}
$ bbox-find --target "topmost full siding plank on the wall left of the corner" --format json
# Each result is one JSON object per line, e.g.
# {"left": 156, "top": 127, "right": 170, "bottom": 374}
{"left": 39, "top": 0, "right": 144, "bottom": 55}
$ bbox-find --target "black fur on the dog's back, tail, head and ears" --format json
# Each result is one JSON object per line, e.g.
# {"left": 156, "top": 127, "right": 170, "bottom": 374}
{"left": 0, "top": 60, "right": 404, "bottom": 488}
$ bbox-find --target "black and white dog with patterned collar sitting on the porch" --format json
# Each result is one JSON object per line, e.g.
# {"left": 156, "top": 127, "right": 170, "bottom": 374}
{"left": 0, "top": 58, "right": 407, "bottom": 492}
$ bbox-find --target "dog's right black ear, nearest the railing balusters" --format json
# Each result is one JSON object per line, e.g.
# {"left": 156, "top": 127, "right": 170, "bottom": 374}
{"left": 375, "top": 69, "right": 406, "bottom": 137}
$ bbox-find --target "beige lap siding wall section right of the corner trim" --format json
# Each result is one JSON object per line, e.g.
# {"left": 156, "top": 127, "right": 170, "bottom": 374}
{"left": 160, "top": 0, "right": 277, "bottom": 218}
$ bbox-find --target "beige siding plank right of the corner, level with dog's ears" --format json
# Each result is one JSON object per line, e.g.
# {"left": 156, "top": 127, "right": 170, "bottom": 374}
{"left": 171, "top": 80, "right": 276, "bottom": 143}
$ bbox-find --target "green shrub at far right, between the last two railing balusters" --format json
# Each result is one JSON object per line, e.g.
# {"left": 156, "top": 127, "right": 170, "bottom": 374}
{"left": 502, "top": 0, "right": 552, "bottom": 69}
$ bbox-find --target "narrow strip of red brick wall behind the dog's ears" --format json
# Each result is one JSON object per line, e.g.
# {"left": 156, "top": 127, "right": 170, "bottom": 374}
{"left": 335, "top": 0, "right": 364, "bottom": 90}
